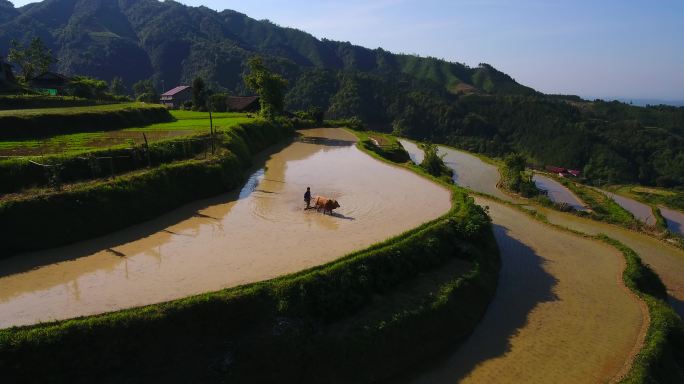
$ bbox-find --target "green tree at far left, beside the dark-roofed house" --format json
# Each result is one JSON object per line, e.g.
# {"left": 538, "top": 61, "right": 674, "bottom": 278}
{"left": 7, "top": 37, "right": 57, "bottom": 81}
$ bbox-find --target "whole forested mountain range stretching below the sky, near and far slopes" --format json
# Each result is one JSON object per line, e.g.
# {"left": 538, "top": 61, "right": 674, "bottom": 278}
{"left": 0, "top": 0, "right": 684, "bottom": 186}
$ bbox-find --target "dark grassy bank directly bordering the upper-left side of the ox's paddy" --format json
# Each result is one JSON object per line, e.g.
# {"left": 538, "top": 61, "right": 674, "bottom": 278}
{"left": 0, "top": 121, "right": 300, "bottom": 257}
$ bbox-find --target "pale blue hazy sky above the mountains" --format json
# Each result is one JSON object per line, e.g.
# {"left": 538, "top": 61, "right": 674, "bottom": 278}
{"left": 9, "top": 0, "right": 684, "bottom": 100}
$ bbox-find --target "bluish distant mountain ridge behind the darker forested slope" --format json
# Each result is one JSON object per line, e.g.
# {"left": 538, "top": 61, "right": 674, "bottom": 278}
{"left": 0, "top": 0, "right": 534, "bottom": 94}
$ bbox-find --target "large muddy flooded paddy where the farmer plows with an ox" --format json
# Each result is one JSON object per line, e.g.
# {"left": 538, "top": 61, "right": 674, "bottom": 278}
{"left": 0, "top": 129, "right": 451, "bottom": 327}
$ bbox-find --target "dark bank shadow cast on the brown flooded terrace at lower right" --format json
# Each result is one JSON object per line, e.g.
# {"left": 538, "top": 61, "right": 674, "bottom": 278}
{"left": 400, "top": 225, "right": 557, "bottom": 384}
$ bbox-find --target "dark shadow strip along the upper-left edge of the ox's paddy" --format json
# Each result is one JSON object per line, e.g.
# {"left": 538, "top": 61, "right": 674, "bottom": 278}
{"left": 0, "top": 140, "right": 292, "bottom": 278}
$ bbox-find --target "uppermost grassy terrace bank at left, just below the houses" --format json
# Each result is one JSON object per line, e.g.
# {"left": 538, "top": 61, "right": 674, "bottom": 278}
{"left": 0, "top": 103, "right": 173, "bottom": 140}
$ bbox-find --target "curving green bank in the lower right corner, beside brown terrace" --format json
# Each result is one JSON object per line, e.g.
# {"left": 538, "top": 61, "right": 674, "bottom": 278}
{"left": 601, "top": 236, "right": 684, "bottom": 384}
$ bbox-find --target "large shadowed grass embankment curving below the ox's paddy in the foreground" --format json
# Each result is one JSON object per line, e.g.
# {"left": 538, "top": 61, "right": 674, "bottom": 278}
{"left": 0, "top": 142, "right": 499, "bottom": 383}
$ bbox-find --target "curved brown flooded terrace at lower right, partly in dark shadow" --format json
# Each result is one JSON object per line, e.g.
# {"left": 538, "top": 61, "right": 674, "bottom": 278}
{"left": 398, "top": 142, "right": 647, "bottom": 383}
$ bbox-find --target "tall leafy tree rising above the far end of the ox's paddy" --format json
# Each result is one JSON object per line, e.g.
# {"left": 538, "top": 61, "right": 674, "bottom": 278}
{"left": 245, "top": 56, "right": 287, "bottom": 118}
